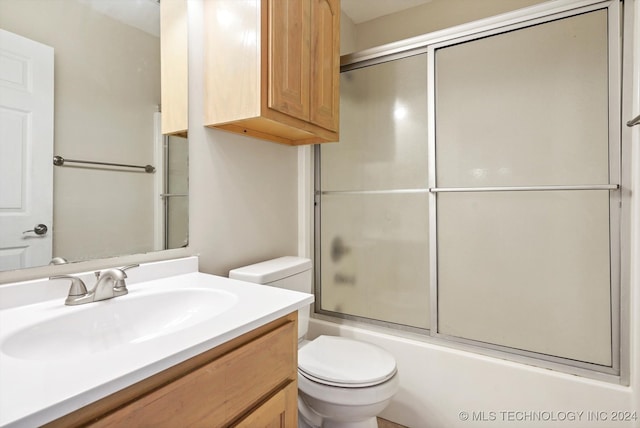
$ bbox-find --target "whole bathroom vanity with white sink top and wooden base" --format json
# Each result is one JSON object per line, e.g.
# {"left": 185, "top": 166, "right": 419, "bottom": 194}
{"left": 0, "top": 258, "right": 313, "bottom": 427}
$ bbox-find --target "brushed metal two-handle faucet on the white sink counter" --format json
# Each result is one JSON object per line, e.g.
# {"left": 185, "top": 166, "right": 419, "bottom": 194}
{"left": 50, "top": 264, "right": 140, "bottom": 306}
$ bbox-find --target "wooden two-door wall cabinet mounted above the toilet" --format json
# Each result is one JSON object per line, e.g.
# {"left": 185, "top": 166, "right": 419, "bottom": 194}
{"left": 204, "top": 0, "right": 340, "bottom": 145}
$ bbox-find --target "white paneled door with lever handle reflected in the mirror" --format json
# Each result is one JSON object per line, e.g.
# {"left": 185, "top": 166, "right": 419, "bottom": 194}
{"left": 0, "top": 30, "right": 53, "bottom": 270}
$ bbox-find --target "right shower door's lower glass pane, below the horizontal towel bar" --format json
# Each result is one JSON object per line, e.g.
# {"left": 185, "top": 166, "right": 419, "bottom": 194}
{"left": 437, "top": 190, "right": 612, "bottom": 366}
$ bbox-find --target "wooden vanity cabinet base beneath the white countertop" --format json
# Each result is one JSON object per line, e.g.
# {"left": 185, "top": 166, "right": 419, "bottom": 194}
{"left": 48, "top": 312, "right": 298, "bottom": 428}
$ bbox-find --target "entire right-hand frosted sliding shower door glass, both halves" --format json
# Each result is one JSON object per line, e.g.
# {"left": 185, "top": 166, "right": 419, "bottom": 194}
{"left": 431, "top": 9, "right": 620, "bottom": 367}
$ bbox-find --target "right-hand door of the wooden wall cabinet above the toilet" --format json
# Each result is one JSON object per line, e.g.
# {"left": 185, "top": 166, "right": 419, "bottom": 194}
{"left": 310, "top": 0, "right": 340, "bottom": 131}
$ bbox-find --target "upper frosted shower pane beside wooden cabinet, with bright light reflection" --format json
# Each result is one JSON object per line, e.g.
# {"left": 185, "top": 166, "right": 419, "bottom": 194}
{"left": 321, "top": 54, "right": 427, "bottom": 190}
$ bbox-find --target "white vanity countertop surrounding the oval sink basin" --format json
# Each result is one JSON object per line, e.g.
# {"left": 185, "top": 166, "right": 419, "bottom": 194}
{"left": 0, "top": 258, "right": 313, "bottom": 427}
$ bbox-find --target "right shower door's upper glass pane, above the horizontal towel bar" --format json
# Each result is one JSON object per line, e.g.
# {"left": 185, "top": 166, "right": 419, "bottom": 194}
{"left": 435, "top": 10, "right": 609, "bottom": 187}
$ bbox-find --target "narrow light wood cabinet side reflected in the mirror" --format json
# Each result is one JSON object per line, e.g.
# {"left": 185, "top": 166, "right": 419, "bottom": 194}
{"left": 160, "top": 0, "right": 189, "bottom": 137}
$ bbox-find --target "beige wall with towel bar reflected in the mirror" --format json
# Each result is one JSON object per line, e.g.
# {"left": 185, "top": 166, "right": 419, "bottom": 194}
{"left": 0, "top": 0, "right": 160, "bottom": 260}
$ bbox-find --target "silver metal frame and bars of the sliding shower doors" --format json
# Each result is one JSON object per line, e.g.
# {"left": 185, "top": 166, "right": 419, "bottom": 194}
{"left": 314, "top": 0, "right": 633, "bottom": 384}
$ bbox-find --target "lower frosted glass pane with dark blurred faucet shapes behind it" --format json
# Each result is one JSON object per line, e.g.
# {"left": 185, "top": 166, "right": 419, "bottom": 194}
{"left": 320, "top": 193, "right": 430, "bottom": 329}
